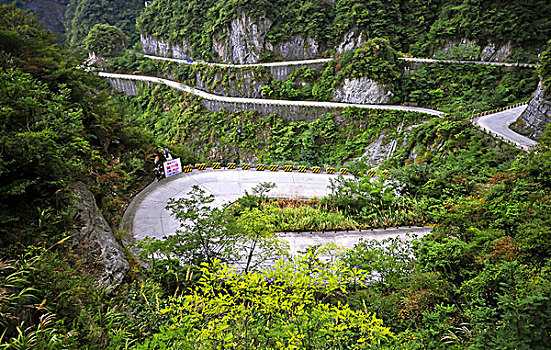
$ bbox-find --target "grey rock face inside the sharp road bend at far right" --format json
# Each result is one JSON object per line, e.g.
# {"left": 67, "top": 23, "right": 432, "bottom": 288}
{"left": 512, "top": 82, "right": 551, "bottom": 139}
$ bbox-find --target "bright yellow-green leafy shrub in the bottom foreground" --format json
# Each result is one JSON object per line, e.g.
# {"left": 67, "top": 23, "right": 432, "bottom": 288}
{"left": 137, "top": 253, "right": 392, "bottom": 349}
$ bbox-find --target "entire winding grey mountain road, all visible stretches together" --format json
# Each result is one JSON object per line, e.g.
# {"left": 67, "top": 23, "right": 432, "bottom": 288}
{"left": 114, "top": 55, "right": 537, "bottom": 254}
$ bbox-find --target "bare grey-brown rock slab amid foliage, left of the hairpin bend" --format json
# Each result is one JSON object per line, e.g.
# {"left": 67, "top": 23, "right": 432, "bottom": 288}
{"left": 72, "top": 182, "right": 130, "bottom": 293}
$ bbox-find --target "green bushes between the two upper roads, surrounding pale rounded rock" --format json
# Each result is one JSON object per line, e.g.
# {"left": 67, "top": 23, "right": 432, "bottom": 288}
{"left": 263, "top": 47, "right": 545, "bottom": 112}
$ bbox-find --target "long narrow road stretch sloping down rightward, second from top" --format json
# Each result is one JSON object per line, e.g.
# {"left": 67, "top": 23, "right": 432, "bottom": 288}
{"left": 98, "top": 72, "right": 444, "bottom": 117}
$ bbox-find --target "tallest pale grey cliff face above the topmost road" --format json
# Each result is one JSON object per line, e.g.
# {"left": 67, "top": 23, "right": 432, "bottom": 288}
{"left": 212, "top": 13, "right": 272, "bottom": 64}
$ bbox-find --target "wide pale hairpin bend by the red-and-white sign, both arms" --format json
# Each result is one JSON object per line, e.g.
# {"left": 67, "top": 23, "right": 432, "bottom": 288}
{"left": 121, "top": 170, "right": 430, "bottom": 255}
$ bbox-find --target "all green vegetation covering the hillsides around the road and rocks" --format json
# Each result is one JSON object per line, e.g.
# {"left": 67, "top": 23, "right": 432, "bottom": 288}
{"left": 0, "top": 0, "right": 551, "bottom": 350}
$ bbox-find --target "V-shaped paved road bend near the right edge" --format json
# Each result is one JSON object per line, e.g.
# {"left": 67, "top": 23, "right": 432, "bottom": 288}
{"left": 474, "top": 105, "right": 538, "bottom": 150}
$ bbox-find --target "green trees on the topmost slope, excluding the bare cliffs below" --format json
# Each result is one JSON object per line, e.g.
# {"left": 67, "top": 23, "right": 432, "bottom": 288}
{"left": 138, "top": 0, "right": 551, "bottom": 59}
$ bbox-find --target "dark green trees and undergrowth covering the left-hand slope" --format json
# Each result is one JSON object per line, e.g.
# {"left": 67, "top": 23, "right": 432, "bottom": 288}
{"left": 0, "top": 6, "right": 162, "bottom": 348}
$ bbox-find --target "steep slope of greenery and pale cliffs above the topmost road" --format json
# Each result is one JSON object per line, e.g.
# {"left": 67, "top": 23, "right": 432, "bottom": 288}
{"left": 138, "top": 0, "right": 551, "bottom": 63}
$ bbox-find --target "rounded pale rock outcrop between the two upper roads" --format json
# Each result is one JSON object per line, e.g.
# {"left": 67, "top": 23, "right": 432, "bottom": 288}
{"left": 331, "top": 77, "right": 394, "bottom": 104}
